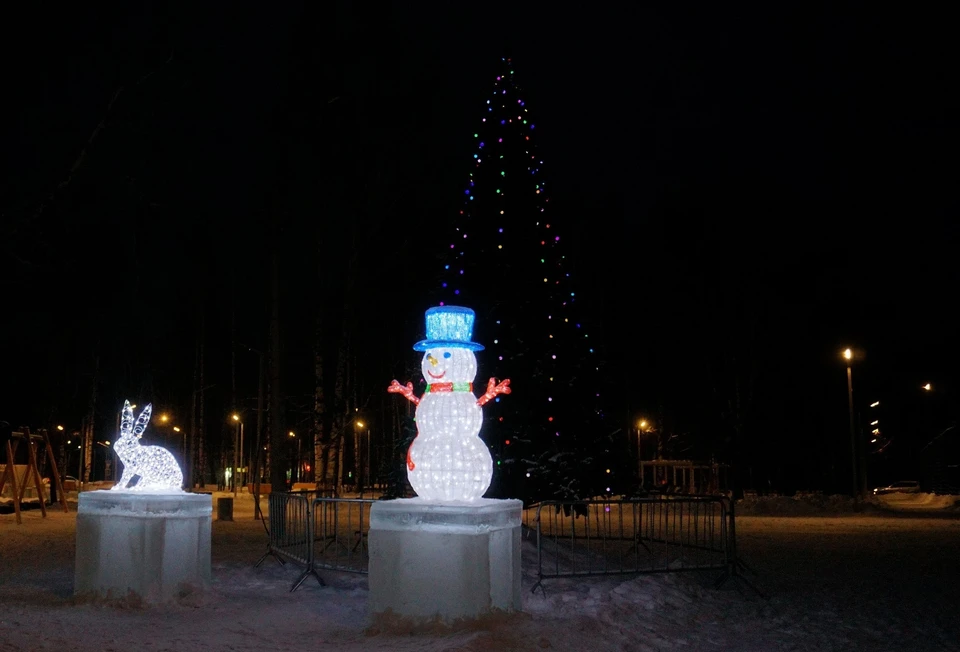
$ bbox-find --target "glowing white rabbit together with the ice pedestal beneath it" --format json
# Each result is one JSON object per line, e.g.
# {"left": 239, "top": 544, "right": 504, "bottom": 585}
{"left": 74, "top": 402, "right": 213, "bottom": 603}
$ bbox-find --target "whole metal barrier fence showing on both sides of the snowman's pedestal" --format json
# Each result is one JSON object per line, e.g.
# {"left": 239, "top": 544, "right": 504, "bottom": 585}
{"left": 256, "top": 491, "right": 763, "bottom": 595}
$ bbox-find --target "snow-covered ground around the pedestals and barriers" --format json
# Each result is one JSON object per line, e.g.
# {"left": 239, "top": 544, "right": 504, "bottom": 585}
{"left": 0, "top": 494, "right": 960, "bottom": 652}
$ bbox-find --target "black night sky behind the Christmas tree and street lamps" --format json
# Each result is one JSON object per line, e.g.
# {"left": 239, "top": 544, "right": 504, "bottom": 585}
{"left": 0, "top": 2, "right": 960, "bottom": 488}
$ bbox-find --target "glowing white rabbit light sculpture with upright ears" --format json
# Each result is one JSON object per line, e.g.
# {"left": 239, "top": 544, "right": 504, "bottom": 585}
{"left": 110, "top": 401, "right": 183, "bottom": 492}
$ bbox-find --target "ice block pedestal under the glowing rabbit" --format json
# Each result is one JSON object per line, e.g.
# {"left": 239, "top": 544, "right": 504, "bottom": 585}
{"left": 74, "top": 491, "right": 213, "bottom": 603}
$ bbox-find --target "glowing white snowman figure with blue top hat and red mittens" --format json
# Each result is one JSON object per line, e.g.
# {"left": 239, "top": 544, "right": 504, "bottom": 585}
{"left": 387, "top": 306, "right": 510, "bottom": 501}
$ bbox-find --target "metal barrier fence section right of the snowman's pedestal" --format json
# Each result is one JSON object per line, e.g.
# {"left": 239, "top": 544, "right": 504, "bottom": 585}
{"left": 525, "top": 496, "right": 737, "bottom": 591}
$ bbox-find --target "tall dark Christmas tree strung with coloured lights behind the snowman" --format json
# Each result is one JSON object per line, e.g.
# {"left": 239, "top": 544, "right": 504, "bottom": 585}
{"left": 434, "top": 57, "right": 612, "bottom": 499}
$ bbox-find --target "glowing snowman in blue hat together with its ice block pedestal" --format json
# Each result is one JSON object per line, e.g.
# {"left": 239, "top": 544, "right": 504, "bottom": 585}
{"left": 376, "top": 306, "right": 523, "bottom": 622}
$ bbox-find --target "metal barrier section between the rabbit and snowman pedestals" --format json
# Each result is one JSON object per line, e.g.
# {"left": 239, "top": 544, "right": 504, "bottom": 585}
{"left": 256, "top": 491, "right": 376, "bottom": 591}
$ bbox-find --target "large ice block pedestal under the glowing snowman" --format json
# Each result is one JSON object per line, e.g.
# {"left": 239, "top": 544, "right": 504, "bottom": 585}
{"left": 368, "top": 498, "right": 523, "bottom": 621}
